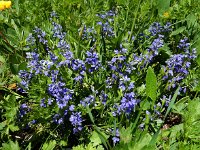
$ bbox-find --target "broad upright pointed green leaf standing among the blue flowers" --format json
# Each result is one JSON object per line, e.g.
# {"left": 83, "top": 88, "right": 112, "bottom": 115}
{"left": 146, "top": 67, "right": 157, "bottom": 102}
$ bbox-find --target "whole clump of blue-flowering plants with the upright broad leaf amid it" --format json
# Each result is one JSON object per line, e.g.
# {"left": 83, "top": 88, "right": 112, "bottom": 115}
{"left": 14, "top": 10, "right": 197, "bottom": 149}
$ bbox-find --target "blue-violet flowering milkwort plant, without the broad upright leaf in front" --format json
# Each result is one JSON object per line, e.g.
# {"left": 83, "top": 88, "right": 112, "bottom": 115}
{"left": 16, "top": 11, "right": 196, "bottom": 146}
